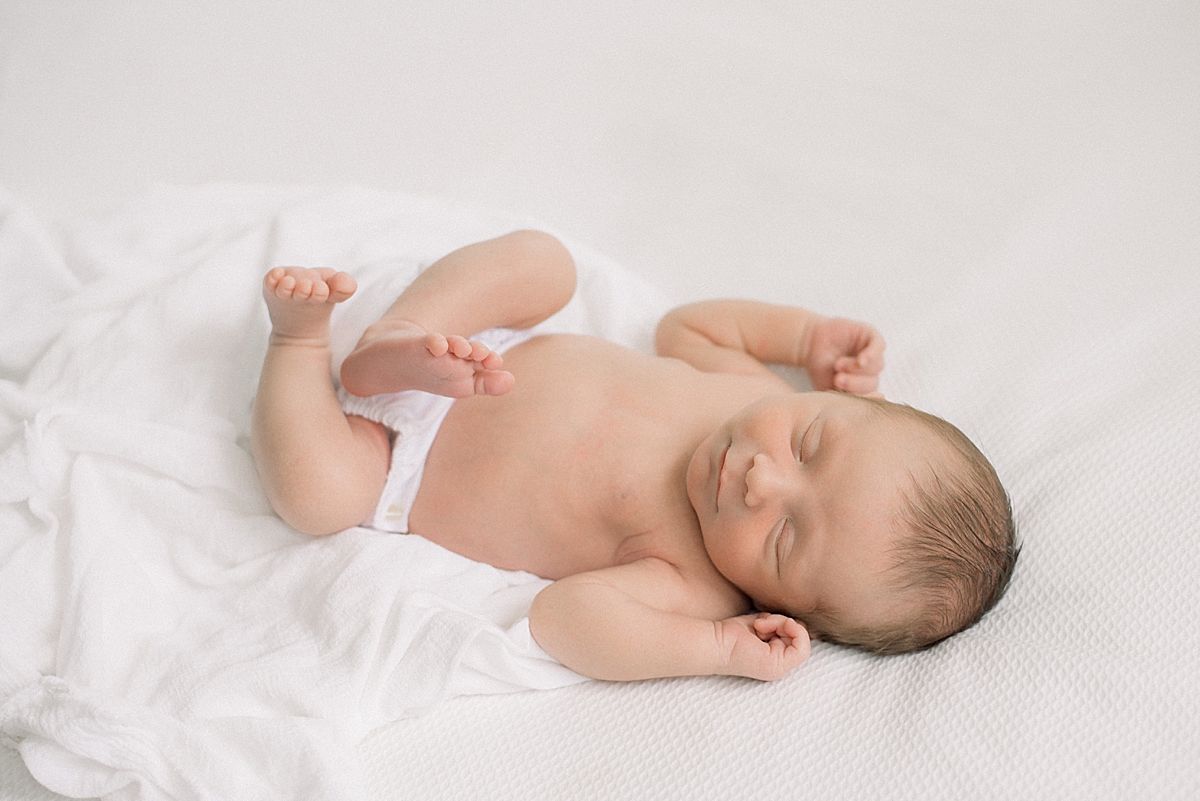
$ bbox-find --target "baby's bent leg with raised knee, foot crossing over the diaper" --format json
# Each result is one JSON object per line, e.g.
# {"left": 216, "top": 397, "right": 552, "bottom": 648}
{"left": 341, "top": 231, "right": 575, "bottom": 398}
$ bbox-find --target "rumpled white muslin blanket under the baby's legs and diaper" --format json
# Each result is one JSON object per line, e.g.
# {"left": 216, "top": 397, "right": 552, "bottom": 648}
{"left": 0, "top": 187, "right": 664, "bottom": 800}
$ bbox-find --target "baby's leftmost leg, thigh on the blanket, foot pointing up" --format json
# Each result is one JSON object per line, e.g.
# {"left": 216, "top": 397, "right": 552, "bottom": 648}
{"left": 252, "top": 267, "right": 390, "bottom": 535}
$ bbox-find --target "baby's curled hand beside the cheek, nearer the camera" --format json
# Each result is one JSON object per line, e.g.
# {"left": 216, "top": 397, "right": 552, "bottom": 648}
{"left": 718, "top": 612, "right": 811, "bottom": 681}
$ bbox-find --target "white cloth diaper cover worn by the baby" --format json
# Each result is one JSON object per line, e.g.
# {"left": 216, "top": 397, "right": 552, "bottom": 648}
{"left": 337, "top": 326, "right": 542, "bottom": 534}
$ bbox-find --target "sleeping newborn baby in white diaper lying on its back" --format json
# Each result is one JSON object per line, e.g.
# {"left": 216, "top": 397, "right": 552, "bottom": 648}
{"left": 253, "top": 231, "right": 1018, "bottom": 680}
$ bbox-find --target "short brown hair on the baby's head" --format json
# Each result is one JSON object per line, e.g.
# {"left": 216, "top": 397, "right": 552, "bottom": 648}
{"left": 805, "top": 398, "right": 1021, "bottom": 655}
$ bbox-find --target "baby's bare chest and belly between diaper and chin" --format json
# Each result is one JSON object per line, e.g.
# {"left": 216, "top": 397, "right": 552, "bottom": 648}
{"left": 409, "top": 336, "right": 690, "bottom": 579}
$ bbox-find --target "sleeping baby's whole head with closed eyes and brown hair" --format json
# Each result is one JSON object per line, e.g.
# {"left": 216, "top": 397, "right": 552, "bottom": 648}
{"left": 688, "top": 392, "right": 1019, "bottom": 654}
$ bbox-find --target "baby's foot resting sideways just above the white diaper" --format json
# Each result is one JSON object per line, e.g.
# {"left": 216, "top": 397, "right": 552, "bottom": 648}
{"left": 342, "top": 320, "right": 514, "bottom": 398}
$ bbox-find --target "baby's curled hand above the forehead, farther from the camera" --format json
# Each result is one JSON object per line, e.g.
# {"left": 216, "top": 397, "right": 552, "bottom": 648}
{"left": 804, "top": 317, "right": 884, "bottom": 395}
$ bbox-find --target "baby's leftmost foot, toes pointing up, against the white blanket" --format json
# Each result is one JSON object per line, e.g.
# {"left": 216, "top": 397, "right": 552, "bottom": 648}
{"left": 263, "top": 267, "right": 358, "bottom": 345}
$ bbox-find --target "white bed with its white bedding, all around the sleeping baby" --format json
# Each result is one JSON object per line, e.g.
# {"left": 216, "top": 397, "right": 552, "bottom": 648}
{"left": 0, "top": 0, "right": 1200, "bottom": 801}
